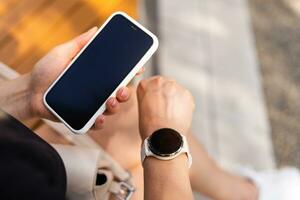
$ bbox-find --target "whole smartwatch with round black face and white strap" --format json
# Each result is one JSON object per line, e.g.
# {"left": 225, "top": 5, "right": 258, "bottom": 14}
{"left": 141, "top": 128, "right": 192, "bottom": 167}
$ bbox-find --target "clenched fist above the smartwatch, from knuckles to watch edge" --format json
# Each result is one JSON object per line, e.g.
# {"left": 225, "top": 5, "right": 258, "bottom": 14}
{"left": 137, "top": 76, "right": 195, "bottom": 139}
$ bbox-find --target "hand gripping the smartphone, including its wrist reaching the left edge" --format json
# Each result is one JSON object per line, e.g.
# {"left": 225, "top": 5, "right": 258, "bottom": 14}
{"left": 0, "top": 27, "right": 144, "bottom": 129}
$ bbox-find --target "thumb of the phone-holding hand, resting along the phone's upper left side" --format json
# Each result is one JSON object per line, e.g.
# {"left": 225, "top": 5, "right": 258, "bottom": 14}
{"left": 54, "top": 27, "right": 97, "bottom": 59}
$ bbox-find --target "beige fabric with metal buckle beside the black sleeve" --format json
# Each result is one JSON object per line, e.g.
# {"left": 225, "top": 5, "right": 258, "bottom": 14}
{"left": 52, "top": 144, "right": 134, "bottom": 200}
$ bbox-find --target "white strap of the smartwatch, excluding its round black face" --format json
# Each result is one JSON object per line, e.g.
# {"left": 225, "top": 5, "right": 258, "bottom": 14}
{"left": 141, "top": 135, "right": 193, "bottom": 168}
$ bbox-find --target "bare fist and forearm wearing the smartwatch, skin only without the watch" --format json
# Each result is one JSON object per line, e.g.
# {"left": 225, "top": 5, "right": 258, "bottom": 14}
{"left": 137, "top": 77, "right": 195, "bottom": 200}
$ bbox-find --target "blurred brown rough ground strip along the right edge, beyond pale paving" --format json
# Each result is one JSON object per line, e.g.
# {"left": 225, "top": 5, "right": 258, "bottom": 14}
{"left": 250, "top": 0, "right": 300, "bottom": 167}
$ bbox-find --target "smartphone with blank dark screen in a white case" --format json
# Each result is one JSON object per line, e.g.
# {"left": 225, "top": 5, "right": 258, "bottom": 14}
{"left": 44, "top": 12, "right": 158, "bottom": 134}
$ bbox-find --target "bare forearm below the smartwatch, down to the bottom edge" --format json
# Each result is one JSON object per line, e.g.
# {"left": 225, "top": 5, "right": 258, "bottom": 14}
{"left": 143, "top": 155, "right": 193, "bottom": 199}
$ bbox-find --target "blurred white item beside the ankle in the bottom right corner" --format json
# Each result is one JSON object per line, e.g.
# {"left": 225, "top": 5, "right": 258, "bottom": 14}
{"left": 239, "top": 167, "right": 300, "bottom": 200}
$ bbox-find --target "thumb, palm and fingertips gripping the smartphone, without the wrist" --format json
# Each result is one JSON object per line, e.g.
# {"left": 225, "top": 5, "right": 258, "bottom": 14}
{"left": 29, "top": 27, "right": 144, "bottom": 129}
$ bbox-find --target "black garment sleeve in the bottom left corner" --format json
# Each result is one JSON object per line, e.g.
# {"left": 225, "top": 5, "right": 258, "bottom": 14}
{"left": 0, "top": 110, "right": 66, "bottom": 200}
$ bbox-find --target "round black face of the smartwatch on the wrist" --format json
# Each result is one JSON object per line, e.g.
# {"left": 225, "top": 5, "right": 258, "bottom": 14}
{"left": 148, "top": 128, "right": 183, "bottom": 156}
